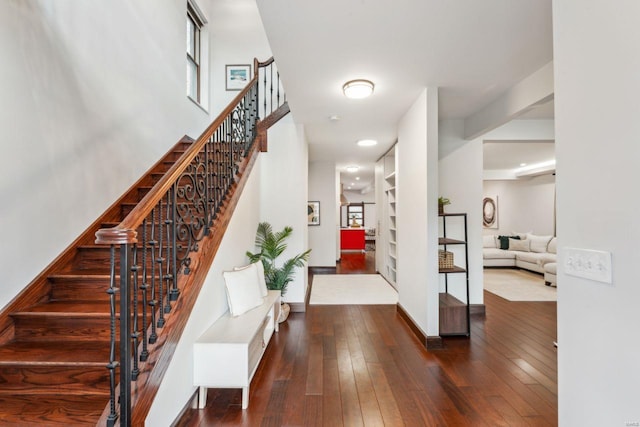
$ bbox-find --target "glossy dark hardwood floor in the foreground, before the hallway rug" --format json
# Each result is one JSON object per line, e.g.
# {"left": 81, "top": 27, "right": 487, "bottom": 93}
{"left": 177, "top": 253, "right": 558, "bottom": 427}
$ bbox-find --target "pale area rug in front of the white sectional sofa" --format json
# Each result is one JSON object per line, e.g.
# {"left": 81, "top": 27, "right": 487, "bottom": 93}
{"left": 484, "top": 268, "right": 558, "bottom": 301}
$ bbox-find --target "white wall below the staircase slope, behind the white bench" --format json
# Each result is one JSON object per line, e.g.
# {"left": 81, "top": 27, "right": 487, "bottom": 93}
{"left": 145, "top": 153, "right": 264, "bottom": 426}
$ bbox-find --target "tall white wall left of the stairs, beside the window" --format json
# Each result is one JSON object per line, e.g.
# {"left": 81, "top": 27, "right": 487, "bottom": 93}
{"left": 0, "top": 0, "right": 215, "bottom": 307}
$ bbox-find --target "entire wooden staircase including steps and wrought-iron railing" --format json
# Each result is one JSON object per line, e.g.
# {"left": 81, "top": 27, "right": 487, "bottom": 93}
{"left": 0, "top": 59, "right": 289, "bottom": 426}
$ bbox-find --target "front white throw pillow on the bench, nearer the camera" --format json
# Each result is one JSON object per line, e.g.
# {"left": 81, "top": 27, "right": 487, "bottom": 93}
{"left": 222, "top": 264, "right": 264, "bottom": 317}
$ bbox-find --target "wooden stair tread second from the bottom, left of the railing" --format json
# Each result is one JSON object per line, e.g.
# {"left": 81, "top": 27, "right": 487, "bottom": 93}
{"left": 0, "top": 341, "right": 109, "bottom": 364}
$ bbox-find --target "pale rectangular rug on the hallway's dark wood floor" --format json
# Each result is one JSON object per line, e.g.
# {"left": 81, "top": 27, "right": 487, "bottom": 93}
{"left": 309, "top": 274, "right": 398, "bottom": 305}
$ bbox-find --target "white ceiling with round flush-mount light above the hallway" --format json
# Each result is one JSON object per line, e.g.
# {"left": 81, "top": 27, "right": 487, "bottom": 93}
{"left": 256, "top": 0, "right": 553, "bottom": 191}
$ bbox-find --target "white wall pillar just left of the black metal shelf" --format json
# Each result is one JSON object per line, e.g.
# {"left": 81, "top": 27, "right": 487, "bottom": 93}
{"left": 396, "top": 88, "right": 439, "bottom": 336}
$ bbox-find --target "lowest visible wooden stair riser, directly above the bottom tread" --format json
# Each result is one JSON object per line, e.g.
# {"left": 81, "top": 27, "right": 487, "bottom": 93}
{"left": 0, "top": 366, "right": 109, "bottom": 395}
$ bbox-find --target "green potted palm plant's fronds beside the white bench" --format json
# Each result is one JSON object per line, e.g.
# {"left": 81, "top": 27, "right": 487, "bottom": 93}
{"left": 247, "top": 222, "right": 311, "bottom": 295}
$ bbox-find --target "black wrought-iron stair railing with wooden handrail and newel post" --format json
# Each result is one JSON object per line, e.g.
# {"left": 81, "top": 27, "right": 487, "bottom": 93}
{"left": 96, "top": 58, "right": 288, "bottom": 426}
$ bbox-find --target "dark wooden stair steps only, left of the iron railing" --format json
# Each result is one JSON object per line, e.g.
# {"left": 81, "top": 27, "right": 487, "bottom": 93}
{"left": 0, "top": 138, "right": 193, "bottom": 426}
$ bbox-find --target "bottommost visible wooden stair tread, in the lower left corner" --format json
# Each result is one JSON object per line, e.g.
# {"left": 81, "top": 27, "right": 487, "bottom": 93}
{"left": 0, "top": 393, "right": 109, "bottom": 427}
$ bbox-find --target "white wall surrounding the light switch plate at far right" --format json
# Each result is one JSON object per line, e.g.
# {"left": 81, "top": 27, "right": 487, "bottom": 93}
{"left": 553, "top": 0, "right": 640, "bottom": 426}
